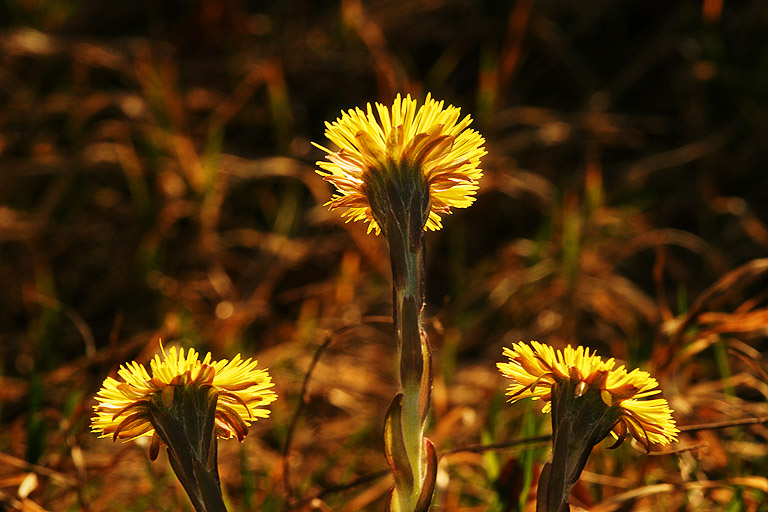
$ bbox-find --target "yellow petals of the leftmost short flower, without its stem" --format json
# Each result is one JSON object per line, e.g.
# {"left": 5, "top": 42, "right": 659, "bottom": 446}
{"left": 91, "top": 344, "right": 277, "bottom": 450}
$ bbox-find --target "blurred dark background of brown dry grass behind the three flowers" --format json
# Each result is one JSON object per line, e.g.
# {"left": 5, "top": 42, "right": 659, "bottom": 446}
{"left": 0, "top": 0, "right": 768, "bottom": 512}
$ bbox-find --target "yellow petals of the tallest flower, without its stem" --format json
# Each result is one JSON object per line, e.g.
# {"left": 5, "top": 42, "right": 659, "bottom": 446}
{"left": 315, "top": 94, "right": 486, "bottom": 235}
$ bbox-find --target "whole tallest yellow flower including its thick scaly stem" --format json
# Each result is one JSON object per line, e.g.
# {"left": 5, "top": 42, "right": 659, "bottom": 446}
{"left": 315, "top": 94, "right": 486, "bottom": 512}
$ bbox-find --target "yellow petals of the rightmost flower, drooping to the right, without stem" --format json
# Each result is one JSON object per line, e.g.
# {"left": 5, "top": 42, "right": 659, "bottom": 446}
{"left": 497, "top": 341, "right": 679, "bottom": 448}
